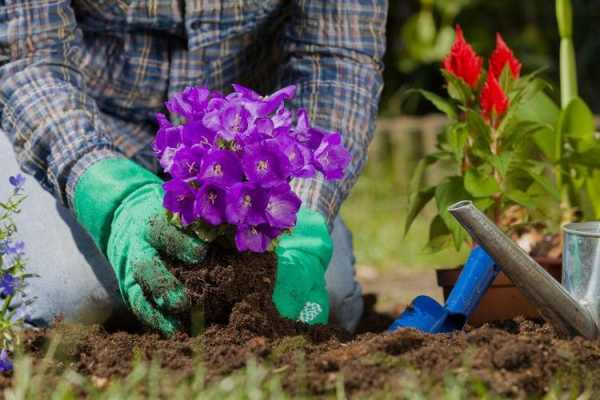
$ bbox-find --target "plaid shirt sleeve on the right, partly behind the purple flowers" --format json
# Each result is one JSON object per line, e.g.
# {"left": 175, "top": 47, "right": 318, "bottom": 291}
{"left": 282, "top": 0, "right": 388, "bottom": 226}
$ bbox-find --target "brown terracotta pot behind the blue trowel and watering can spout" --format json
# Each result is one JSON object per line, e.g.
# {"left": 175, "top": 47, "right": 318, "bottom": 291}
{"left": 436, "top": 257, "right": 562, "bottom": 326}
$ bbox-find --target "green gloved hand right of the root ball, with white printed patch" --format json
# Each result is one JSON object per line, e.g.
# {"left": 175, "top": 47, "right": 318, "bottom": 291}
{"left": 273, "top": 208, "right": 333, "bottom": 324}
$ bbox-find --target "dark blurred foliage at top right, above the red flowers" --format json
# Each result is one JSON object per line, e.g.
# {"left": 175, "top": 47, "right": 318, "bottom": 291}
{"left": 380, "top": 0, "right": 600, "bottom": 116}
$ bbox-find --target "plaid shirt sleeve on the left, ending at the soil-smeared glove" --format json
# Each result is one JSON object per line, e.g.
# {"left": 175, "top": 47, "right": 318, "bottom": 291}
{"left": 0, "top": 0, "right": 123, "bottom": 206}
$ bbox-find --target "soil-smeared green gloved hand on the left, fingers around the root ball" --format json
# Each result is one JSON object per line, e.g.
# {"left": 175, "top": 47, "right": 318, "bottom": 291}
{"left": 74, "top": 159, "right": 207, "bottom": 335}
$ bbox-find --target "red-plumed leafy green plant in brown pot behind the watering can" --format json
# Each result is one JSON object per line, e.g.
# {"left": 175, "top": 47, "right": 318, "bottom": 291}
{"left": 406, "top": 0, "right": 600, "bottom": 325}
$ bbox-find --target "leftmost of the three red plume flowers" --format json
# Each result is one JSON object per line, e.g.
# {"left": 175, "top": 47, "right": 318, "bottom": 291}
{"left": 442, "top": 25, "right": 483, "bottom": 88}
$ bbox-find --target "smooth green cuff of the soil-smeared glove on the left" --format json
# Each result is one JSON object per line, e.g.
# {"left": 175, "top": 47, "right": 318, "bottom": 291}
{"left": 73, "top": 158, "right": 162, "bottom": 254}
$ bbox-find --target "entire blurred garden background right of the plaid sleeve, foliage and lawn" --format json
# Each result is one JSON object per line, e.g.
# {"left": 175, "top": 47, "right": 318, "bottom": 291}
{"left": 342, "top": 0, "right": 600, "bottom": 268}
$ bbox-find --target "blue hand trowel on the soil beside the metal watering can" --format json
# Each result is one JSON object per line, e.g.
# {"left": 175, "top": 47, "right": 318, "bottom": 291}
{"left": 389, "top": 247, "right": 500, "bottom": 333}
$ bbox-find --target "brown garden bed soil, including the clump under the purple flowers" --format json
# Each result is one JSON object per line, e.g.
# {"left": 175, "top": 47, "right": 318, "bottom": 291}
{"left": 7, "top": 252, "right": 600, "bottom": 398}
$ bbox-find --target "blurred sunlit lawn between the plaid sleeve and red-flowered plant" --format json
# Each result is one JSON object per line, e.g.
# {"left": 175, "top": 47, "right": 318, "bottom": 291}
{"left": 341, "top": 157, "right": 466, "bottom": 268}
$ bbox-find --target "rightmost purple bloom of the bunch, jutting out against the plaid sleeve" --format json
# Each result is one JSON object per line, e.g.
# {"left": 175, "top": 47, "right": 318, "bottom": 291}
{"left": 314, "top": 133, "right": 352, "bottom": 180}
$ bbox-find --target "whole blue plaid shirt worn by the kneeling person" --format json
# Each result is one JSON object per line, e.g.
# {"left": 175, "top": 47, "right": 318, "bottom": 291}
{"left": 0, "top": 0, "right": 387, "bottom": 227}
